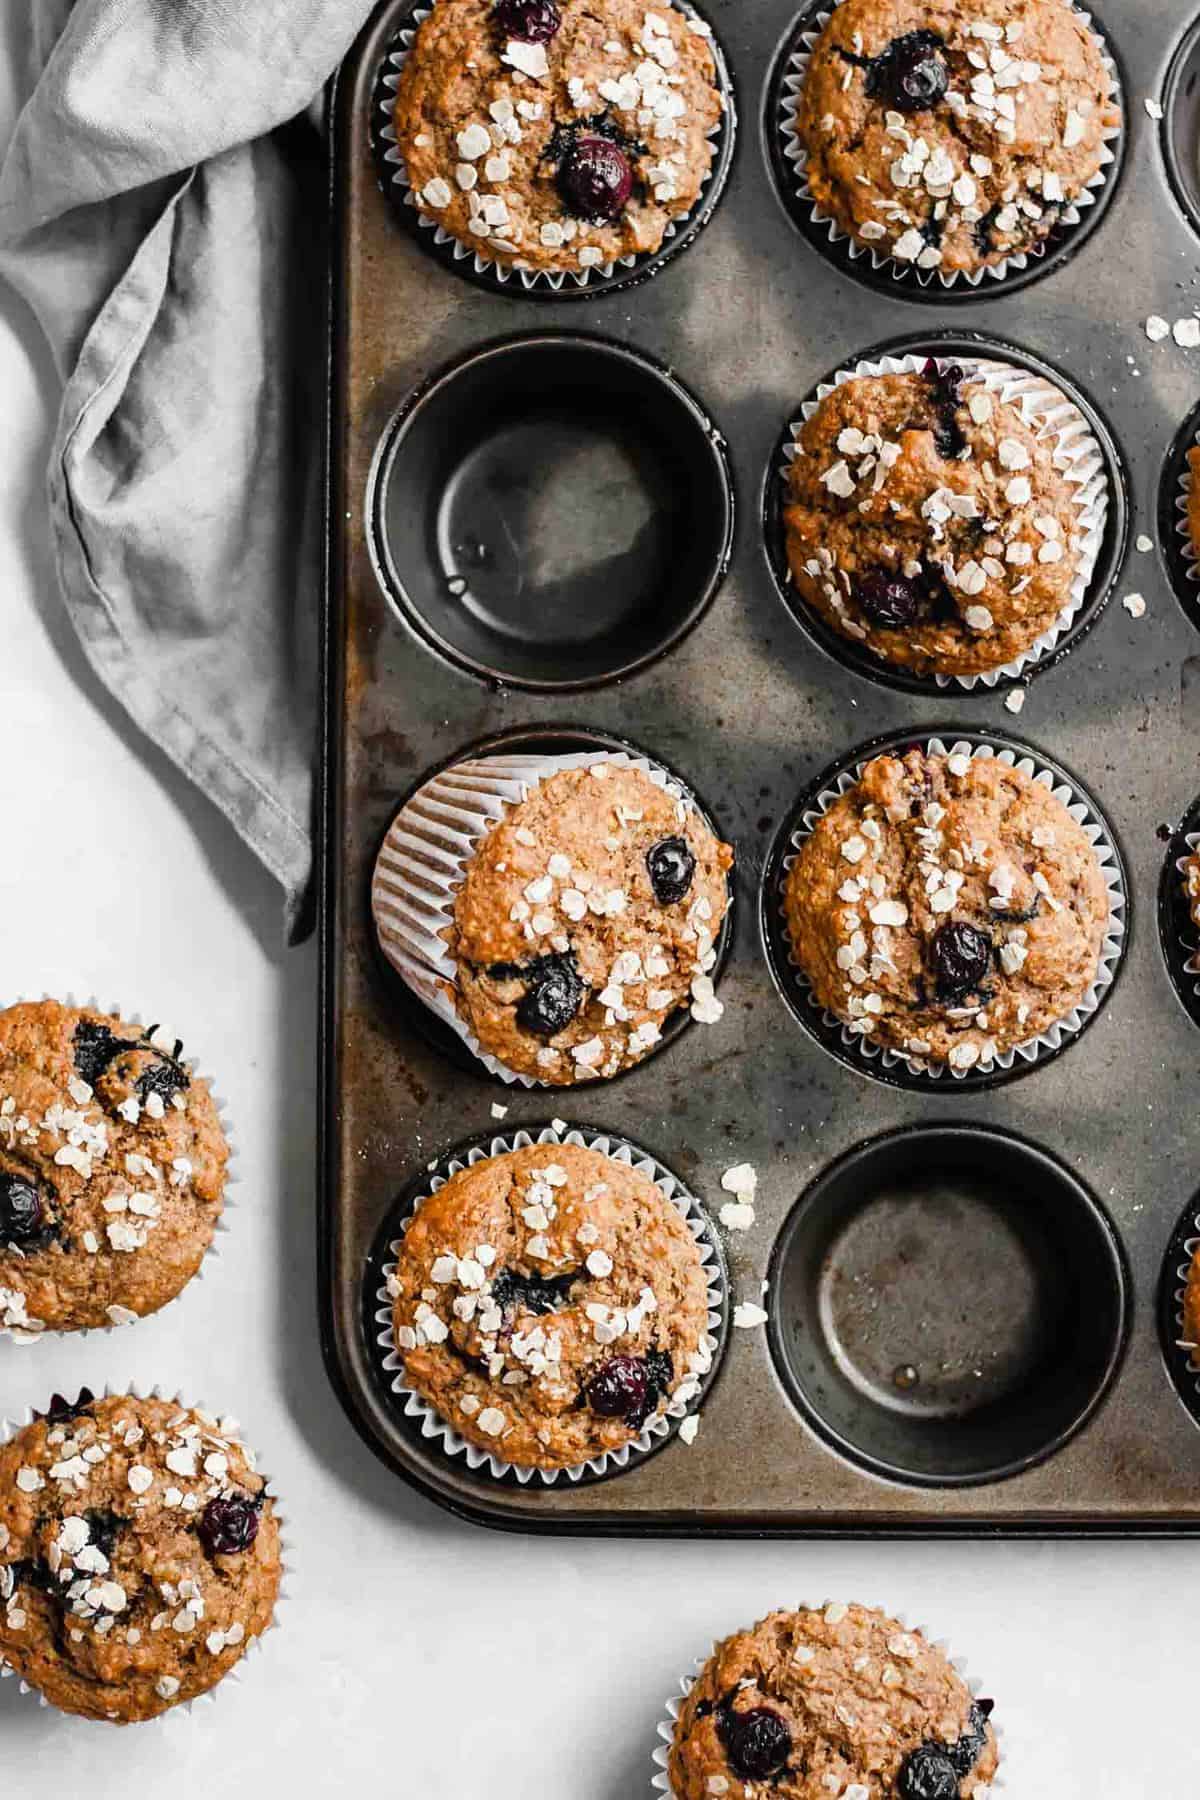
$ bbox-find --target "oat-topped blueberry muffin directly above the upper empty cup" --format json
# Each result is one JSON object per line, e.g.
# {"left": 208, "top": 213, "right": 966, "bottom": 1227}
{"left": 394, "top": 0, "right": 723, "bottom": 272}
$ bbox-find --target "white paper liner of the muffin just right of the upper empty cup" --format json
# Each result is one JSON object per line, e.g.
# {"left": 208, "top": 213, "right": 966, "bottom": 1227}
{"left": 777, "top": 355, "right": 1108, "bottom": 693}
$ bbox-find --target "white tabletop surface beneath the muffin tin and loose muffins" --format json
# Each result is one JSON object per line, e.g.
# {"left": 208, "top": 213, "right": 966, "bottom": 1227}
{"left": 0, "top": 21, "right": 1200, "bottom": 1800}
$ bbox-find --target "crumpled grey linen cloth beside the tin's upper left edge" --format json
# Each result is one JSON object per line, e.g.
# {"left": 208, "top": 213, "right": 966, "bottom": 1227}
{"left": 0, "top": 0, "right": 371, "bottom": 929}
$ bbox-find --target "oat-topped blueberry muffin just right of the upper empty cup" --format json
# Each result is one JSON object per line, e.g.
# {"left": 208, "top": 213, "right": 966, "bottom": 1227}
{"left": 783, "top": 362, "right": 1081, "bottom": 675}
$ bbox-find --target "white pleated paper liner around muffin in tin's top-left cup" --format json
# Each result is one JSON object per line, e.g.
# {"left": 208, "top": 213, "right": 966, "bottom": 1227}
{"left": 372, "top": 0, "right": 738, "bottom": 293}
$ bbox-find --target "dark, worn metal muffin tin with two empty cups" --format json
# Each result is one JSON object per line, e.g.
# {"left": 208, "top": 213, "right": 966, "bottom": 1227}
{"left": 318, "top": 0, "right": 1200, "bottom": 1535}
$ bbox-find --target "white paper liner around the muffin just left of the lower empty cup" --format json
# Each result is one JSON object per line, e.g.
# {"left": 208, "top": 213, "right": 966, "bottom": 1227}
{"left": 374, "top": 1125, "right": 725, "bottom": 1487}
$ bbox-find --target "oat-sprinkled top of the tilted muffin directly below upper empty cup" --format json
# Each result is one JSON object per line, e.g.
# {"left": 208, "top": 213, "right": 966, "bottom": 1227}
{"left": 448, "top": 761, "right": 734, "bottom": 1087}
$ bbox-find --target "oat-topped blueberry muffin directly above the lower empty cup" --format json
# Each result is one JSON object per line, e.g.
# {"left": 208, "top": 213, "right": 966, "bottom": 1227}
{"left": 784, "top": 749, "right": 1110, "bottom": 1071}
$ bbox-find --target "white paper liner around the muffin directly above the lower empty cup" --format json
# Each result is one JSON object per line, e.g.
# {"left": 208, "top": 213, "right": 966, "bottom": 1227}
{"left": 781, "top": 738, "right": 1126, "bottom": 1082}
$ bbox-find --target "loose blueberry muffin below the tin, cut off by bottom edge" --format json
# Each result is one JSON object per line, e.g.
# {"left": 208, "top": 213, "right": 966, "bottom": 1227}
{"left": 667, "top": 1604, "right": 1000, "bottom": 1800}
